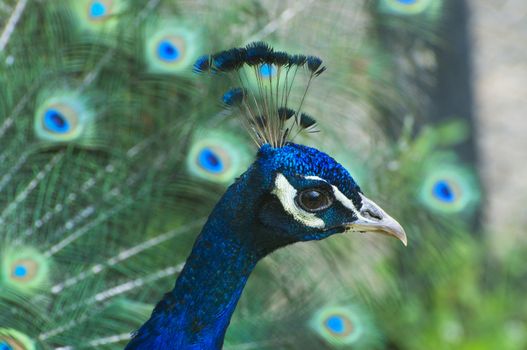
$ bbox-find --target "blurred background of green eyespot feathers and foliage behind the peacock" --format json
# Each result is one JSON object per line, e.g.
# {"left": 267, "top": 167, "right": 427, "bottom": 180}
{"left": 0, "top": 0, "right": 527, "bottom": 350}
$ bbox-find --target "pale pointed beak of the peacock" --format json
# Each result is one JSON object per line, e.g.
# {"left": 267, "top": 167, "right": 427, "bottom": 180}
{"left": 348, "top": 193, "right": 408, "bottom": 246}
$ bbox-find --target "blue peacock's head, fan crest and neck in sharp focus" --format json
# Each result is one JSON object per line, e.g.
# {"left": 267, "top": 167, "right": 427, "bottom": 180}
{"left": 126, "top": 42, "right": 407, "bottom": 349}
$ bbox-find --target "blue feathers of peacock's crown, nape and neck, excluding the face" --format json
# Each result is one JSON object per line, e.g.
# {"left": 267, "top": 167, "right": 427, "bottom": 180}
{"left": 127, "top": 144, "right": 358, "bottom": 349}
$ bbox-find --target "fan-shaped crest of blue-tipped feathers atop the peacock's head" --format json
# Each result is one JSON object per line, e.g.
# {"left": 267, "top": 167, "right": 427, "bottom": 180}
{"left": 194, "top": 42, "right": 326, "bottom": 147}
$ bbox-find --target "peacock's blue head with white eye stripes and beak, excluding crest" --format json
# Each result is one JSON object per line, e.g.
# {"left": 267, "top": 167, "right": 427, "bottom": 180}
{"left": 248, "top": 143, "right": 407, "bottom": 245}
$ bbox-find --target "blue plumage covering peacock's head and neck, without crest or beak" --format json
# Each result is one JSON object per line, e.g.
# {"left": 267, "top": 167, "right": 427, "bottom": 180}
{"left": 127, "top": 143, "right": 404, "bottom": 350}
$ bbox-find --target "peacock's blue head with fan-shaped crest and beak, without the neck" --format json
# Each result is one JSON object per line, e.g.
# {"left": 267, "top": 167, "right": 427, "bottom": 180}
{"left": 198, "top": 42, "right": 407, "bottom": 250}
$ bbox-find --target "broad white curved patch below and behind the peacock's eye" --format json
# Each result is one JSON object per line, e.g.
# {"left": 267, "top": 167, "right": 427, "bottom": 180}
{"left": 272, "top": 173, "right": 325, "bottom": 228}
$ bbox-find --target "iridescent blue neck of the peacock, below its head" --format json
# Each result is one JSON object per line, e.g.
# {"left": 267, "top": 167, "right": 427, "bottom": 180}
{"left": 126, "top": 173, "right": 267, "bottom": 350}
